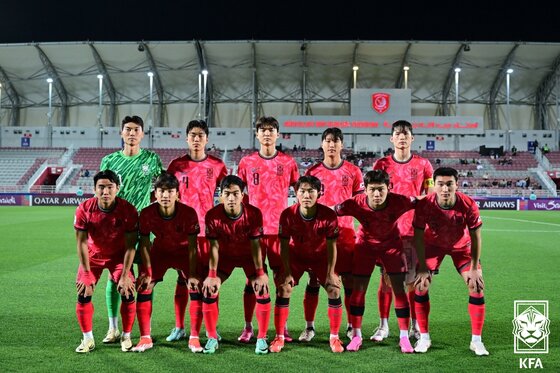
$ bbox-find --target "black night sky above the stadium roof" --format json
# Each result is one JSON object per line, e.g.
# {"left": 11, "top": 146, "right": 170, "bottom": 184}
{"left": 0, "top": 0, "right": 560, "bottom": 43}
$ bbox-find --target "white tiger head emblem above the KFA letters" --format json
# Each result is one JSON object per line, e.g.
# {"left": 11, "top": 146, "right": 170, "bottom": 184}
{"left": 513, "top": 306, "right": 550, "bottom": 348}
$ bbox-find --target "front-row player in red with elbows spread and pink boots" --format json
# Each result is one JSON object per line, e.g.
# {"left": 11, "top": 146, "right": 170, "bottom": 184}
{"left": 334, "top": 170, "right": 415, "bottom": 353}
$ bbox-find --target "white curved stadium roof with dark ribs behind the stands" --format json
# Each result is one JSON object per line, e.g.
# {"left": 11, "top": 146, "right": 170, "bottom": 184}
{"left": 0, "top": 40, "right": 560, "bottom": 129}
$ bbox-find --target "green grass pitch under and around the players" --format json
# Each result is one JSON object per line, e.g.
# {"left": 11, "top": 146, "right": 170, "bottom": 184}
{"left": 0, "top": 207, "right": 560, "bottom": 372}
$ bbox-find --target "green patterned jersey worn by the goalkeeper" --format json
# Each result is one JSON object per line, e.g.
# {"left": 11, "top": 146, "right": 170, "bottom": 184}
{"left": 100, "top": 149, "right": 163, "bottom": 212}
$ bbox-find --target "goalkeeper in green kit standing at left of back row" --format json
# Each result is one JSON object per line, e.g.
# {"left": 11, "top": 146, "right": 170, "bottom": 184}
{"left": 99, "top": 115, "right": 163, "bottom": 347}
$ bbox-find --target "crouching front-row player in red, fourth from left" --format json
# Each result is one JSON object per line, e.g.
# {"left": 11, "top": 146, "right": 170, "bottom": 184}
{"left": 270, "top": 176, "right": 344, "bottom": 352}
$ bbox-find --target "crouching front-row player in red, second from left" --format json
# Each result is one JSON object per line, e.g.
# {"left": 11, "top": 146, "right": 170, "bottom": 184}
{"left": 132, "top": 172, "right": 202, "bottom": 352}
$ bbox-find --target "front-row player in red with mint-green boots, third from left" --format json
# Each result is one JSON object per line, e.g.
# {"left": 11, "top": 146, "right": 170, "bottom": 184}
{"left": 202, "top": 175, "right": 270, "bottom": 355}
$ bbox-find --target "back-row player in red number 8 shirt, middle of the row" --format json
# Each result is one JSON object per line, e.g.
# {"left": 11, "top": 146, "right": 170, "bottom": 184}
{"left": 237, "top": 117, "right": 299, "bottom": 343}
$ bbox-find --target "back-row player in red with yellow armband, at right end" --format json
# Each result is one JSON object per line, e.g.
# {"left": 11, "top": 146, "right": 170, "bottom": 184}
{"left": 370, "top": 120, "right": 434, "bottom": 342}
